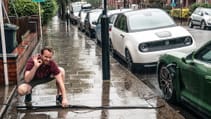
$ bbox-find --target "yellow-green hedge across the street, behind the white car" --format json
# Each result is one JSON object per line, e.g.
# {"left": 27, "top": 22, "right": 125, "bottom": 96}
{"left": 170, "top": 8, "right": 189, "bottom": 19}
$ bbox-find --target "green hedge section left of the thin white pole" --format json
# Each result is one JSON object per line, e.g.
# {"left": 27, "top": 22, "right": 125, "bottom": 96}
{"left": 9, "top": 0, "right": 39, "bottom": 17}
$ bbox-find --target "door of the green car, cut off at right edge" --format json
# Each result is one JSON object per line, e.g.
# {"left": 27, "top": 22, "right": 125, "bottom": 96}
{"left": 196, "top": 43, "right": 211, "bottom": 112}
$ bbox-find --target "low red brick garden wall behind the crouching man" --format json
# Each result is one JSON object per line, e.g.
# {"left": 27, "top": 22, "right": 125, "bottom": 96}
{"left": 0, "top": 33, "right": 38, "bottom": 85}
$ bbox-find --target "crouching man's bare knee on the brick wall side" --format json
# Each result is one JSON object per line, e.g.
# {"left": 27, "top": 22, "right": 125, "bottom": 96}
{"left": 18, "top": 83, "right": 31, "bottom": 96}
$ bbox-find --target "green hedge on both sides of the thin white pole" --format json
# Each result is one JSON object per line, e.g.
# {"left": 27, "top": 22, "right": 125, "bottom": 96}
{"left": 9, "top": 0, "right": 58, "bottom": 25}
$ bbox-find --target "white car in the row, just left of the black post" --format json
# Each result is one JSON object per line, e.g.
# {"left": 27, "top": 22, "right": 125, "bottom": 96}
{"left": 84, "top": 9, "right": 102, "bottom": 38}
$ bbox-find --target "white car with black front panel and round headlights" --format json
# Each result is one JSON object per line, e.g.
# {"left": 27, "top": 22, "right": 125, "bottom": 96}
{"left": 110, "top": 8, "right": 196, "bottom": 72}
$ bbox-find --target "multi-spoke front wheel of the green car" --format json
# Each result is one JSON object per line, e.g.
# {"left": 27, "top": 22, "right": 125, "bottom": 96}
{"left": 158, "top": 65, "right": 176, "bottom": 103}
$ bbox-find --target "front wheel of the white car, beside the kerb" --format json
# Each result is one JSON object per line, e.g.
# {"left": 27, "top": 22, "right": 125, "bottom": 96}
{"left": 125, "top": 50, "right": 136, "bottom": 73}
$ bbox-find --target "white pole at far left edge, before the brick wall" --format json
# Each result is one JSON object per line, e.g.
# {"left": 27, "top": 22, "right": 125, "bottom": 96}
{"left": 0, "top": 0, "right": 9, "bottom": 86}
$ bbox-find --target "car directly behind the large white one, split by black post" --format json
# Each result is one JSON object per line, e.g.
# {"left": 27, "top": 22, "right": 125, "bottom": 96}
{"left": 95, "top": 8, "right": 133, "bottom": 44}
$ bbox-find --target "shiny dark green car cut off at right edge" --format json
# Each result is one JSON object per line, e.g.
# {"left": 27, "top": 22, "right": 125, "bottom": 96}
{"left": 157, "top": 41, "right": 211, "bottom": 117}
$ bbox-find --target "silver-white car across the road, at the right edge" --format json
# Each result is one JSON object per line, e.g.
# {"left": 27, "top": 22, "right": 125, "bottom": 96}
{"left": 189, "top": 7, "right": 211, "bottom": 29}
